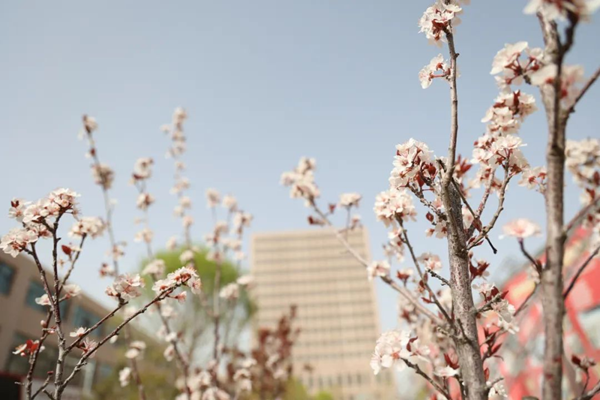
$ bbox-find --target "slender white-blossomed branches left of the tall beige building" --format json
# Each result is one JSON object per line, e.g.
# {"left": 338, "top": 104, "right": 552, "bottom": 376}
{"left": 0, "top": 108, "right": 298, "bottom": 400}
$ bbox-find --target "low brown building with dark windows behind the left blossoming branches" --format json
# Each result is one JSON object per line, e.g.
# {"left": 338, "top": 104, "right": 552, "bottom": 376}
{"left": 0, "top": 253, "right": 125, "bottom": 400}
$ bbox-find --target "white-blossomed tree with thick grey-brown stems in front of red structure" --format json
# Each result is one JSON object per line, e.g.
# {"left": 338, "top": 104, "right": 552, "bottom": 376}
{"left": 281, "top": 0, "right": 600, "bottom": 400}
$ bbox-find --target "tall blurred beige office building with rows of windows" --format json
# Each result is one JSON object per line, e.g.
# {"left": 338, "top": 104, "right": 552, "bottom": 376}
{"left": 251, "top": 228, "right": 396, "bottom": 400}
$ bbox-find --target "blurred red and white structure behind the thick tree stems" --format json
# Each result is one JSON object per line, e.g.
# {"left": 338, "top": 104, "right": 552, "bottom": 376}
{"left": 500, "top": 229, "right": 600, "bottom": 399}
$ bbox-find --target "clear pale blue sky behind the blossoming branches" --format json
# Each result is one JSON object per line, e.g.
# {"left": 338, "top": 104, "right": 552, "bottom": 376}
{"left": 0, "top": 0, "right": 600, "bottom": 328}
